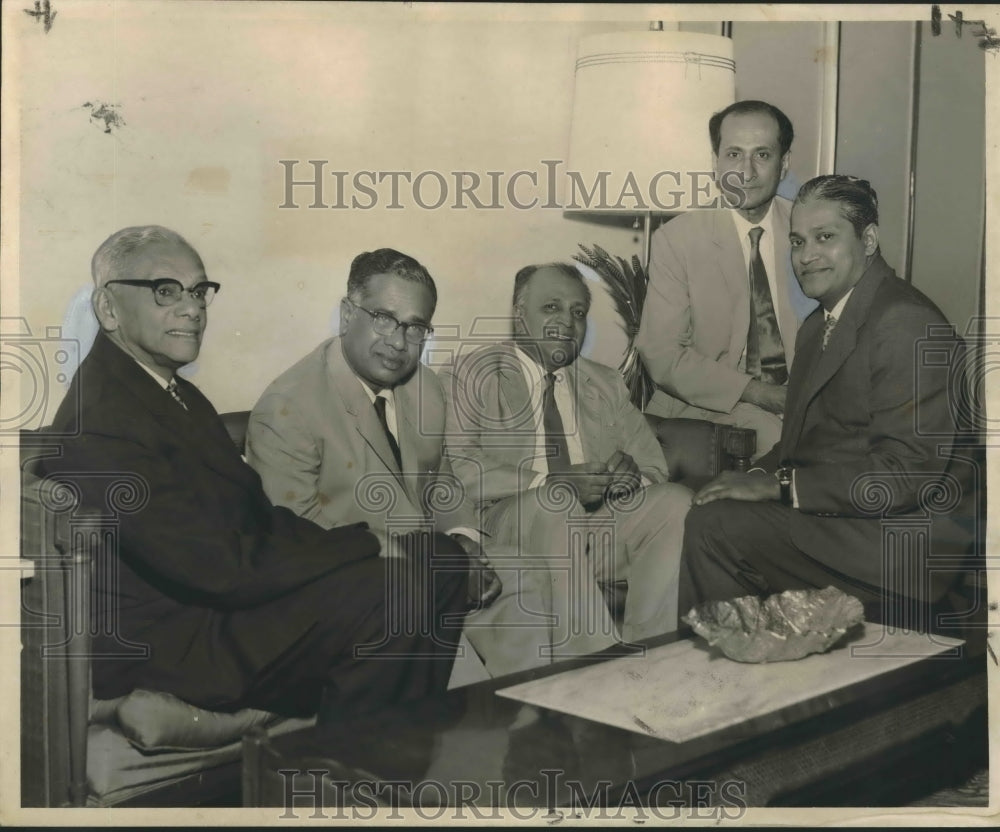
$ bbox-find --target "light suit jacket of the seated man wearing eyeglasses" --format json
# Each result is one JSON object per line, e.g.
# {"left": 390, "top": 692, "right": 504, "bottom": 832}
{"left": 246, "top": 338, "right": 477, "bottom": 531}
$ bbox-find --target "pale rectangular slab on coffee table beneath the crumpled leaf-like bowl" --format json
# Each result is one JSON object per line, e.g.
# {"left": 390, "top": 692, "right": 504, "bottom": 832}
{"left": 497, "top": 623, "right": 962, "bottom": 742}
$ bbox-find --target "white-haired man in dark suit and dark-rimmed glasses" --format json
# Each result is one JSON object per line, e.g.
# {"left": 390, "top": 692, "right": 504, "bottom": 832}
{"left": 41, "top": 226, "right": 467, "bottom": 720}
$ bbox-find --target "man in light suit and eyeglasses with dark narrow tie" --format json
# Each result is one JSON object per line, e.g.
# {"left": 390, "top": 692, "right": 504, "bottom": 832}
{"left": 247, "top": 248, "right": 611, "bottom": 685}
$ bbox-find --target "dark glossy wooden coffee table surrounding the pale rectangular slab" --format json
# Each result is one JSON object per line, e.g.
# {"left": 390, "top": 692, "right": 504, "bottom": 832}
{"left": 243, "top": 632, "right": 987, "bottom": 820}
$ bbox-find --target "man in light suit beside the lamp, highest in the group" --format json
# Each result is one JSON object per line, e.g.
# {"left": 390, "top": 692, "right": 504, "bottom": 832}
{"left": 636, "top": 101, "right": 816, "bottom": 462}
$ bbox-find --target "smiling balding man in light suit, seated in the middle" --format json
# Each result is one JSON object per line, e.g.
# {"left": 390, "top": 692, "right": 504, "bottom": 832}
{"left": 441, "top": 263, "right": 691, "bottom": 641}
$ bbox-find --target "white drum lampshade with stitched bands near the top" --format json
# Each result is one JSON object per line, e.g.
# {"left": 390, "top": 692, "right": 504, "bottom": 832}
{"left": 563, "top": 31, "right": 736, "bottom": 214}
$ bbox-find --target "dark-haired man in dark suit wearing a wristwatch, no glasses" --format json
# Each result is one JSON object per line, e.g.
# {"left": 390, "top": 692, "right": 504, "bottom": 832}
{"left": 680, "top": 176, "right": 969, "bottom": 623}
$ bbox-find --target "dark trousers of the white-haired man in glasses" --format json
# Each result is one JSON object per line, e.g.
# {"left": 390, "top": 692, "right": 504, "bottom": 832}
{"left": 101, "top": 535, "right": 469, "bottom": 721}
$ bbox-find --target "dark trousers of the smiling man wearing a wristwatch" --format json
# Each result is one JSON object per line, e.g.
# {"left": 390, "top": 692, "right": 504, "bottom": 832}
{"left": 678, "top": 500, "right": 920, "bottom": 626}
